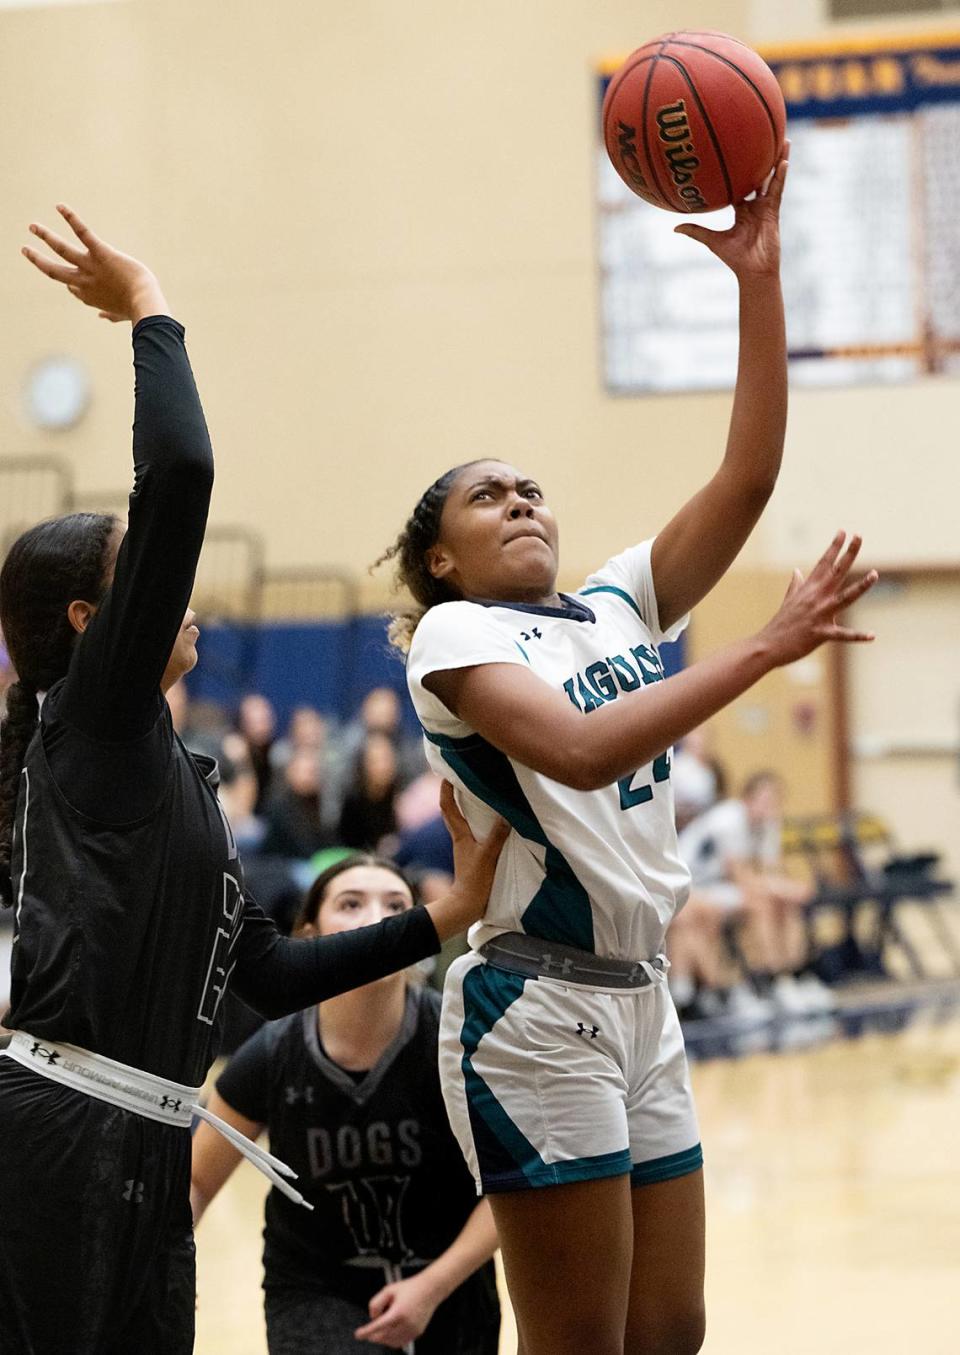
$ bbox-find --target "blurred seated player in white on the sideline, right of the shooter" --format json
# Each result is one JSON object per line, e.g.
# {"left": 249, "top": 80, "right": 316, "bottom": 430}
{"left": 668, "top": 771, "right": 833, "bottom": 1015}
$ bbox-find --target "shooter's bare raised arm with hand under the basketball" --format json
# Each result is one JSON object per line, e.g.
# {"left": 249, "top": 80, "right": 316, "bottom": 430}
{"left": 652, "top": 142, "right": 789, "bottom": 630}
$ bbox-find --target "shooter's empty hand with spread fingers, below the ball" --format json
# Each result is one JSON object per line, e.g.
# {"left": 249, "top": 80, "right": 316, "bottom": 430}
{"left": 761, "top": 531, "right": 879, "bottom": 667}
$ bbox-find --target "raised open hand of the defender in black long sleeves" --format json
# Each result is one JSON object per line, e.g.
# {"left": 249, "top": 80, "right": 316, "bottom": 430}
{"left": 23, "top": 203, "right": 169, "bottom": 324}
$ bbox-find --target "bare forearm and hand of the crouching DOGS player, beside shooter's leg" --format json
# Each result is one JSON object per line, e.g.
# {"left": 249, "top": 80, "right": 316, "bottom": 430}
{"left": 354, "top": 1199, "right": 496, "bottom": 1347}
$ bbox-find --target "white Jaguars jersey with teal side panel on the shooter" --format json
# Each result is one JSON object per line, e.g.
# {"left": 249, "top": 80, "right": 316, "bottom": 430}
{"left": 407, "top": 541, "right": 689, "bottom": 959}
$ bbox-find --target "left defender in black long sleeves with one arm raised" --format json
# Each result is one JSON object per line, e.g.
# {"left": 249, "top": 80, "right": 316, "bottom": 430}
{"left": 0, "top": 207, "right": 502, "bottom": 1355}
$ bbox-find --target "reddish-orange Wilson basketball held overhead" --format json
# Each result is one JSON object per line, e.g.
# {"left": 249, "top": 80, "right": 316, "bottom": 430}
{"left": 603, "top": 31, "right": 786, "bottom": 213}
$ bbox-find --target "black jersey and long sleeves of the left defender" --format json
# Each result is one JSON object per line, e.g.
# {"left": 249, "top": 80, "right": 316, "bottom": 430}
{"left": 5, "top": 316, "right": 438, "bottom": 1085}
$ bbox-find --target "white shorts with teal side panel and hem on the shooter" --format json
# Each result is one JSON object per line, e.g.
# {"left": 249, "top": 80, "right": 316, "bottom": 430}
{"left": 439, "top": 953, "right": 704, "bottom": 1194}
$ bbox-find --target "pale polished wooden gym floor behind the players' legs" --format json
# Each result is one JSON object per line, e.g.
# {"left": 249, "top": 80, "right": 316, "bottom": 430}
{"left": 197, "top": 1004, "right": 960, "bottom": 1355}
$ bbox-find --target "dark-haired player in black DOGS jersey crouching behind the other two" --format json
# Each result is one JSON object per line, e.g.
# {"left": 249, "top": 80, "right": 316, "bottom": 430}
{"left": 193, "top": 855, "right": 500, "bottom": 1355}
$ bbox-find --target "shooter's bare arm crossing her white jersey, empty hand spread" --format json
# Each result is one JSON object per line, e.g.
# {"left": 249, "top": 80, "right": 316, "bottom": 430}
{"left": 423, "top": 533, "right": 877, "bottom": 790}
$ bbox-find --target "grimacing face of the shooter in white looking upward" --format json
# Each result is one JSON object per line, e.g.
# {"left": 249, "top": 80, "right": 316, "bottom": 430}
{"left": 427, "top": 461, "right": 559, "bottom": 602}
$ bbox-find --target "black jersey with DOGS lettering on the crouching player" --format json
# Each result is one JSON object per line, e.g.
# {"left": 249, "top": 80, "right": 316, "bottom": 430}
{"left": 217, "top": 986, "right": 496, "bottom": 1314}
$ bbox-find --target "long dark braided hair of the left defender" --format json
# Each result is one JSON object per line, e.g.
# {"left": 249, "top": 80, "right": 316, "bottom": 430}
{"left": 0, "top": 512, "right": 118, "bottom": 906}
